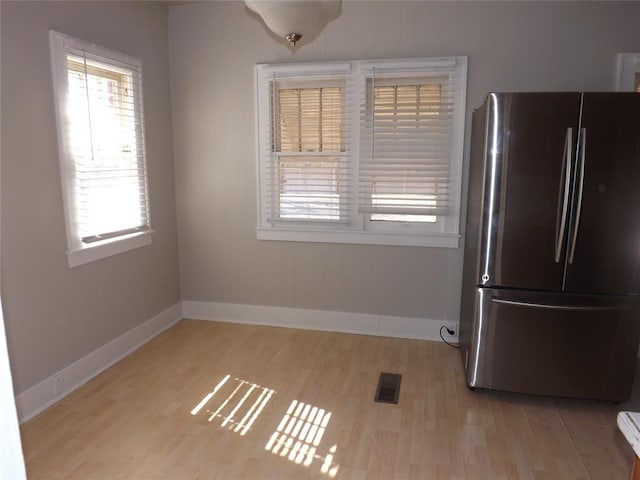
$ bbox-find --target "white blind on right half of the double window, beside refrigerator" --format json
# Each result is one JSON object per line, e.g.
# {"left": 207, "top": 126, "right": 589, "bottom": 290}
{"left": 358, "top": 67, "right": 456, "bottom": 222}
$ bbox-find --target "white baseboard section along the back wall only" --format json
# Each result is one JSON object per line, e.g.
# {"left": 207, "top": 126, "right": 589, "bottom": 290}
{"left": 182, "top": 301, "right": 457, "bottom": 341}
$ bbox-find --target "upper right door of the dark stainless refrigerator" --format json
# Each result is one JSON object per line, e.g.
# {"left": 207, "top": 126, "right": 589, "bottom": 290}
{"left": 564, "top": 93, "right": 640, "bottom": 294}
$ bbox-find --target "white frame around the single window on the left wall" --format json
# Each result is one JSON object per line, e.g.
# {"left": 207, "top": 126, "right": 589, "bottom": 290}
{"left": 49, "top": 30, "right": 153, "bottom": 267}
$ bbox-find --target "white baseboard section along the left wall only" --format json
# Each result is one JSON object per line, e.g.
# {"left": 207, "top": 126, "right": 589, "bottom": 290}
{"left": 16, "top": 303, "right": 182, "bottom": 423}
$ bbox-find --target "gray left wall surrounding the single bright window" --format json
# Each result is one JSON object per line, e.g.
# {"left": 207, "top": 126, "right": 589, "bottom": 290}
{"left": 0, "top": 1, "right": 180, "bottom": 394}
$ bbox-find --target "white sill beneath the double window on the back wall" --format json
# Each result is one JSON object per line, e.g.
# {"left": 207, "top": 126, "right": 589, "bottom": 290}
{"left": 256, "top": 227, "right": 460, "bottom": 248}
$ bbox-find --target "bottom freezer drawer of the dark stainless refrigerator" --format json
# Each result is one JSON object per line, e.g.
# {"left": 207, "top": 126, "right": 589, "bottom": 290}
{"left": 463, "top": 288, "right": 640, "bottom": 401}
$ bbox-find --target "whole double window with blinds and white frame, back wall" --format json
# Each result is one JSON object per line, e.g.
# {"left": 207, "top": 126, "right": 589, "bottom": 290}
{"left": 256, "top": 57, "right": 467, "bottom": 247}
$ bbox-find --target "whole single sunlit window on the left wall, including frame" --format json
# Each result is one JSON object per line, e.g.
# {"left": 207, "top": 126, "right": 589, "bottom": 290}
{"left": 50, "top": 31, "right": 151, "bottom": 267}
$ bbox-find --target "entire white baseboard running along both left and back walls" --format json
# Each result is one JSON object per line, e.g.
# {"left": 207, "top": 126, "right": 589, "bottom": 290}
{"left": 16, "top": 301, "right": 457, "bottom": 423}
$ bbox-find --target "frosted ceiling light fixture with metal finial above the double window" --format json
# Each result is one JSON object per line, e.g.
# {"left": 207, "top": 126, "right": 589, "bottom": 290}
{"left": 244, "top": 0, "right": 342, "bottom": 47}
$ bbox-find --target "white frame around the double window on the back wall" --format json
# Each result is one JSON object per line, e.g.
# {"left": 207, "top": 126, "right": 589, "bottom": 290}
{"left": 255, "top": 56, "right": 467, "bottom": 248}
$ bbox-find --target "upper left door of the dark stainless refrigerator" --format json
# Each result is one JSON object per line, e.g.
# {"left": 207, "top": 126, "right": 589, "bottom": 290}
{"left": 480, "top": 93, "right": 580, "bottom": 291}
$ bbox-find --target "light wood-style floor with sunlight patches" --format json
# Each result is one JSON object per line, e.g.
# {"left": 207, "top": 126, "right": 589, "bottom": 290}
{"left": 22, "top": 320, "right": 633, "bottom": 480}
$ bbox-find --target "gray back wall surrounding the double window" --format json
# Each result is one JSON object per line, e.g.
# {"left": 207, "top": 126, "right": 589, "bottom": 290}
{"left": 169, "top": 1, "right": 640, "bottom": 320}
